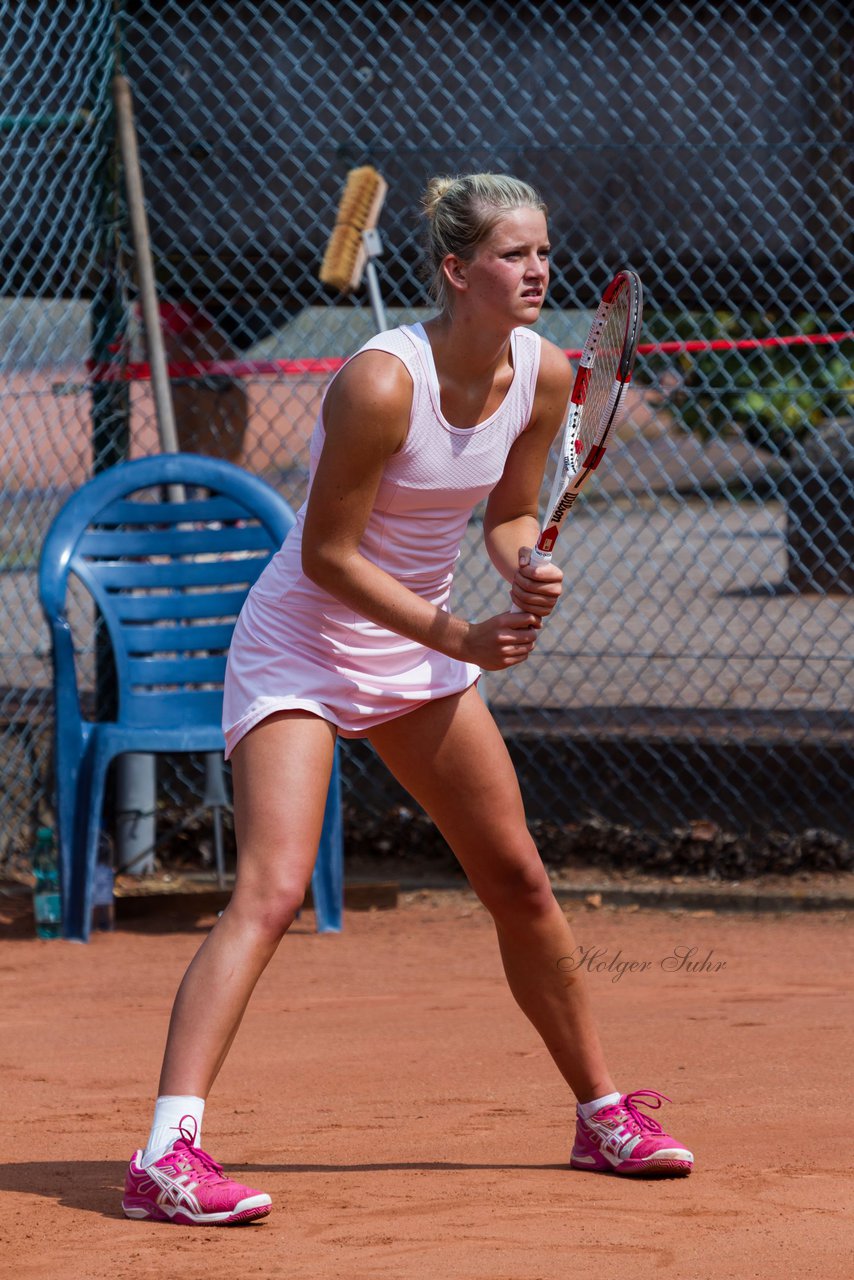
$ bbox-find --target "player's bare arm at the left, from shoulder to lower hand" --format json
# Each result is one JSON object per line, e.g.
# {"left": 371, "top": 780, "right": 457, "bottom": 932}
{"left": 302, "top": 351, "right": 535, "bottom": 669}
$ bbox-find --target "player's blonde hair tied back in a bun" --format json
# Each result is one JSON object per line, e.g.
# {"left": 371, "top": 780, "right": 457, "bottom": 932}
{"left": 421, "top": 173, "right": 547, "bottom": 307}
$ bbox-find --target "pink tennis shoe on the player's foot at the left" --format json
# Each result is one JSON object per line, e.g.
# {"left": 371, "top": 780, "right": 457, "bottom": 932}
{"left": 122, "top": 1116, "right": 273, "bottom": 1226}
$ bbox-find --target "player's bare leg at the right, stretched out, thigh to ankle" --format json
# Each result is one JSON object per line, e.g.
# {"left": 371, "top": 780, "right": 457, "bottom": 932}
{"left": 370, "top": 689, "right": 615, "bottom": 1102}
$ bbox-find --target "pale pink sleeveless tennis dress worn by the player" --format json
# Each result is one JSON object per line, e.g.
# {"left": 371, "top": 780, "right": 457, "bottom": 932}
{"left": 223, "top": 324, "right": 540, "bottom": 758}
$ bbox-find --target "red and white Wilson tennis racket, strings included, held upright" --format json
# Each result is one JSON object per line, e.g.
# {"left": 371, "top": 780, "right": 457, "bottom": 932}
{"left": 531, "top": 271, "right": 644, "bottom": 564}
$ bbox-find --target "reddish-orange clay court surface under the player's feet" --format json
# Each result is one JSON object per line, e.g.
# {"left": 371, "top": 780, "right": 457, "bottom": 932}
{"left": 0, "top": 892, "right": 854, "bottom": 1280}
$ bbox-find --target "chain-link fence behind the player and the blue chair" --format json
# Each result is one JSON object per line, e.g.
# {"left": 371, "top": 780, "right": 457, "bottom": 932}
{"left": 0, "top": 0, "right": 854, "bottom": 859}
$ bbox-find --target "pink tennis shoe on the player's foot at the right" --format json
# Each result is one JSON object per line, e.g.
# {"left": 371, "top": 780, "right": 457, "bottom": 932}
{"left": 570, "top": 1089, "right": 694, "bottom": 1178}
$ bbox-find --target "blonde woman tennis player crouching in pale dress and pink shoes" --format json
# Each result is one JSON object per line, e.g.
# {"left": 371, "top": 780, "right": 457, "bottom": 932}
{"left": 123, "top": 174, "right": 693, "bottom": 1225}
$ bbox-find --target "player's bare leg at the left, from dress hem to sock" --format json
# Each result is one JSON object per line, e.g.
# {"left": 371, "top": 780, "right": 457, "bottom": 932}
{"left": 159, "top": 712, "right": 335, "bottom": 1098}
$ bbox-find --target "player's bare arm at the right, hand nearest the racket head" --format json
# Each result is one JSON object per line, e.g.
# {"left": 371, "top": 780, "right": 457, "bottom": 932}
{"left": 484, "top": 342, "right": 572, "bottom": 618}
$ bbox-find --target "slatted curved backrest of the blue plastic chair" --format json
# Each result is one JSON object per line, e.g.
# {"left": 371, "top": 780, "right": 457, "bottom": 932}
{"left": 38, "top": 453, "right": 294, "bottom": 727}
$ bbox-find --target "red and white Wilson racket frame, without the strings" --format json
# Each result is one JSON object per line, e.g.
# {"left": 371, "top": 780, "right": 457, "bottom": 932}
{"left": 531, "top": 270, "right": 644, "bottom": 564}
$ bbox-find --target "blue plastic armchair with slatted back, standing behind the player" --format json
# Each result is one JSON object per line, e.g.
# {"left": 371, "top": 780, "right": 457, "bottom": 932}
{"left": 38, "top": 453, "right": 343, "bottom": 942}
